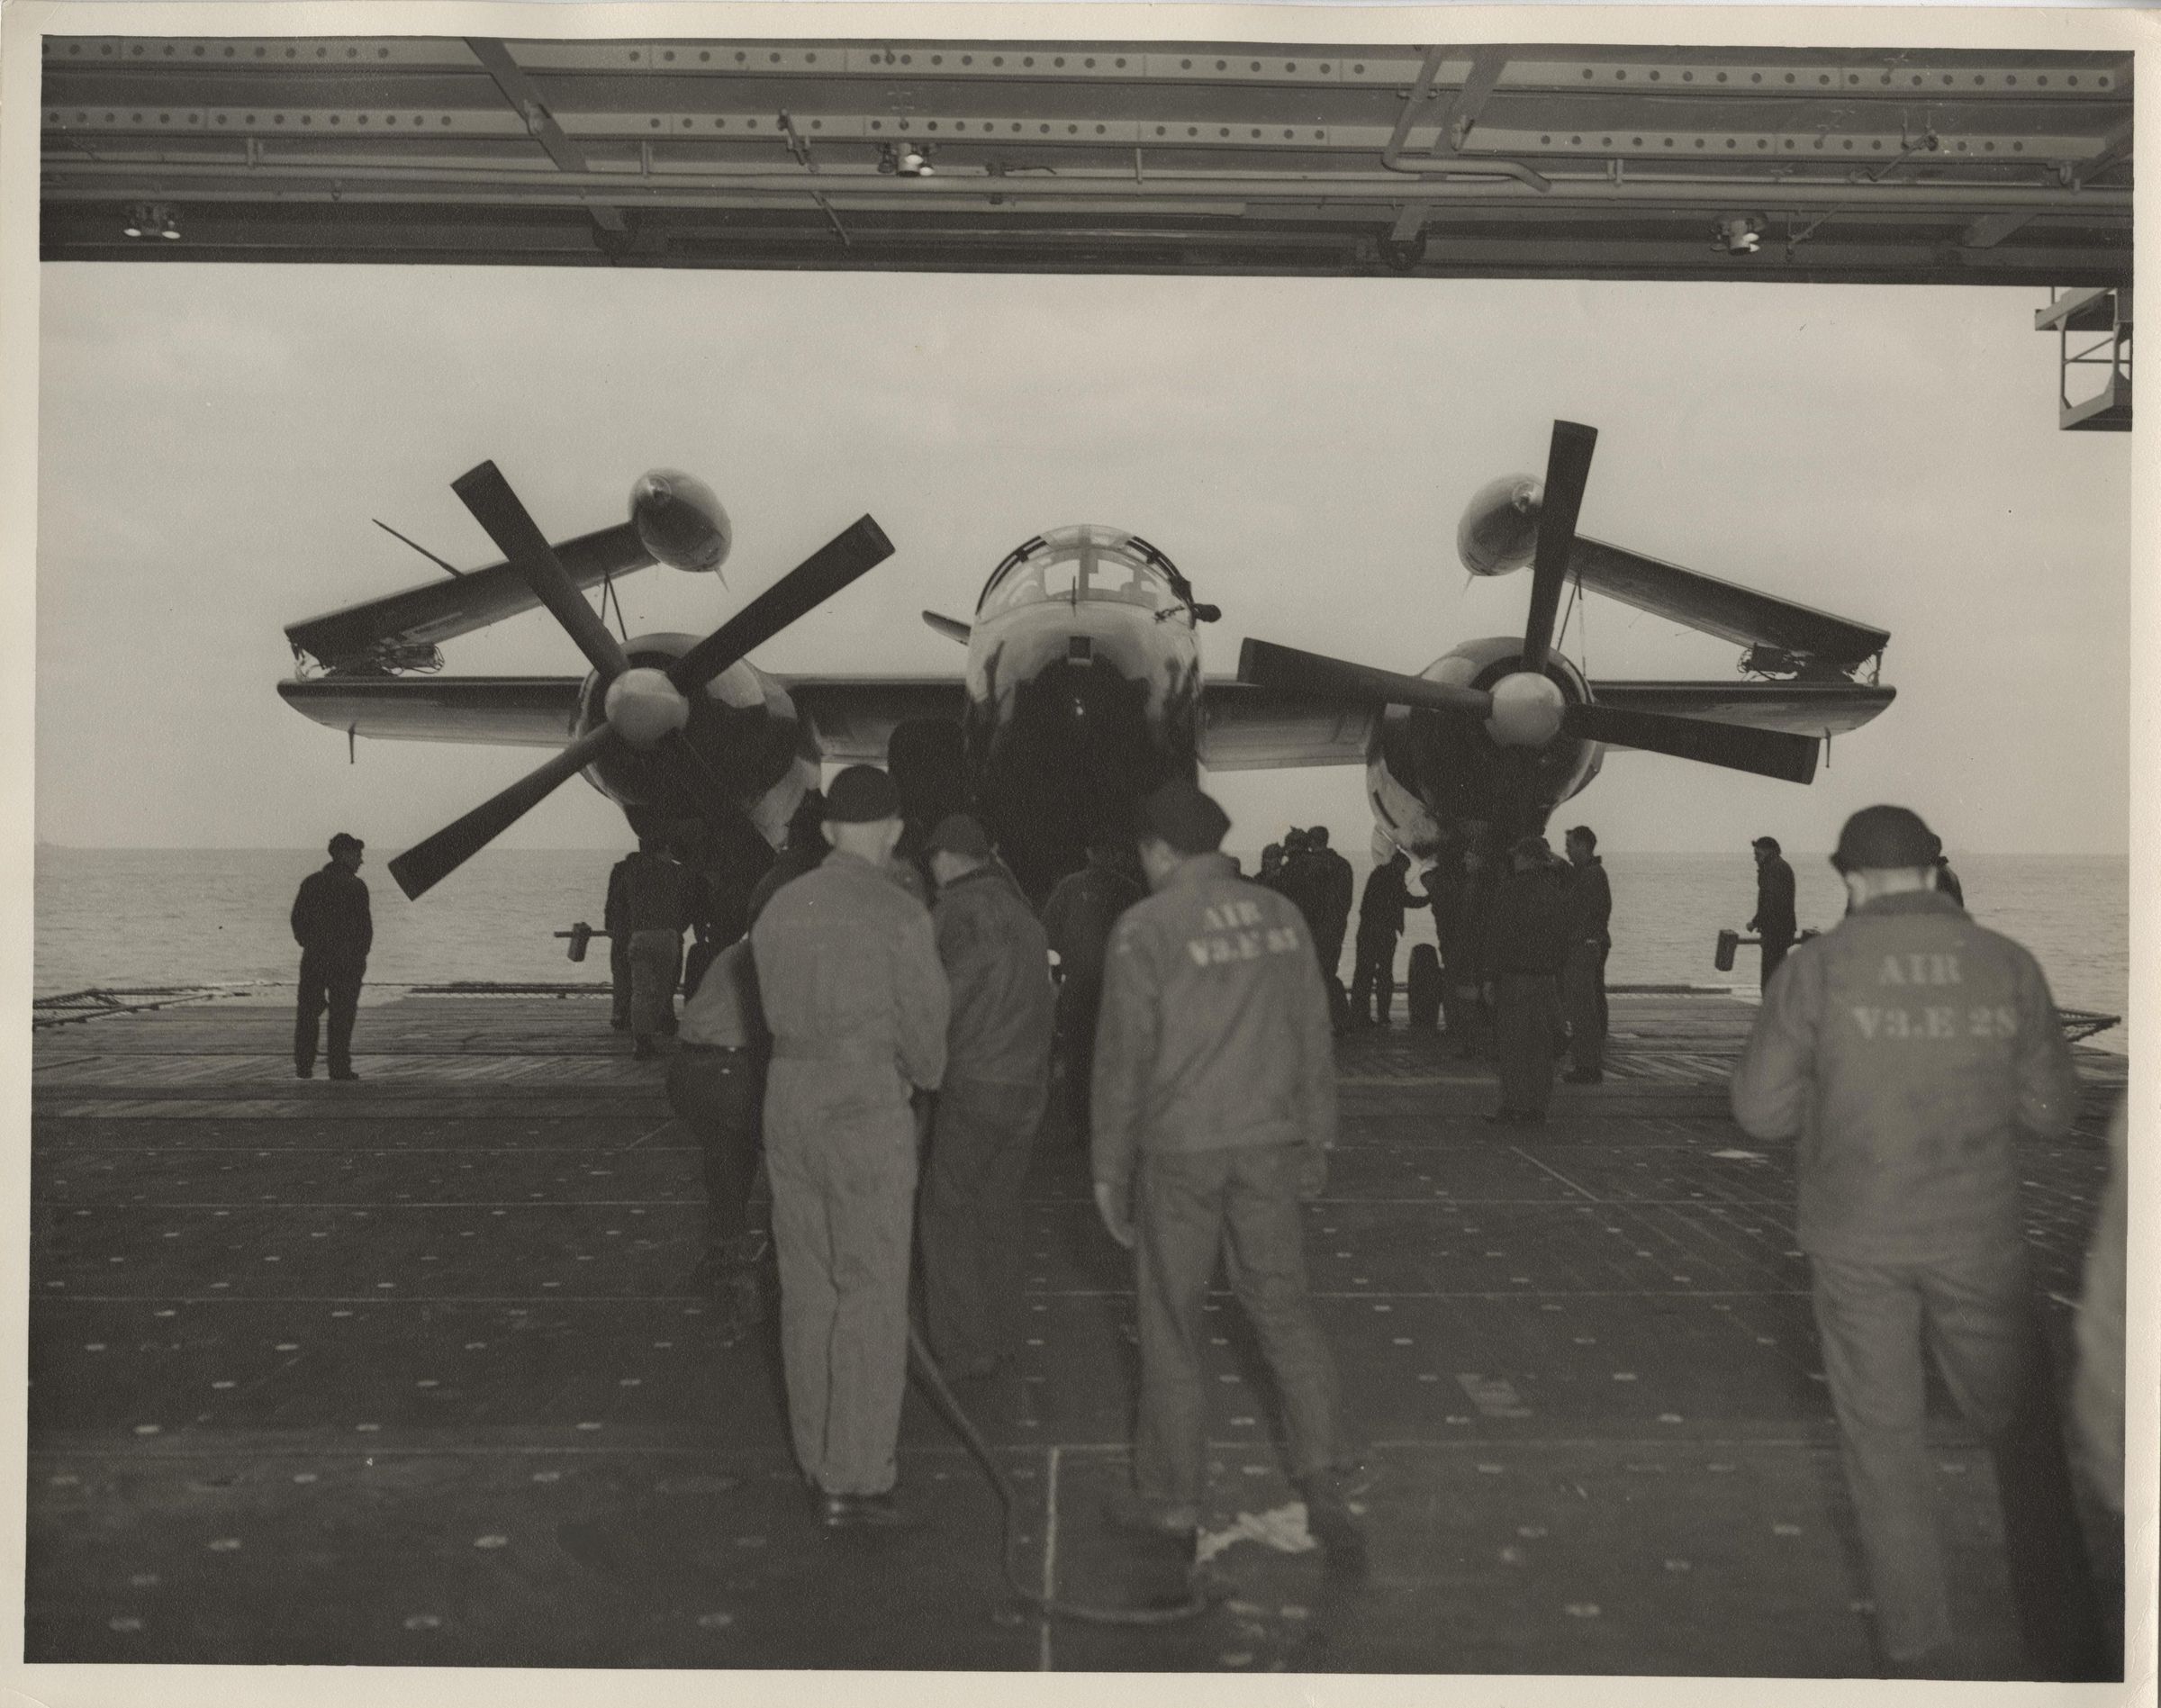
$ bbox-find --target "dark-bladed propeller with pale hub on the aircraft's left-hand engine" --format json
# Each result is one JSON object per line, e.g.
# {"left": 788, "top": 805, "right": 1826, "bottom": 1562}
{"left": 389, "top": 463, "right": 892, "bottom": 899}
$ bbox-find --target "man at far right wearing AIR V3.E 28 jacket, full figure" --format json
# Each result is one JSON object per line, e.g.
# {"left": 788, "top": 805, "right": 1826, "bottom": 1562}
{"left": 1733, "top": 807, "right": 2120, "bottom": 1680}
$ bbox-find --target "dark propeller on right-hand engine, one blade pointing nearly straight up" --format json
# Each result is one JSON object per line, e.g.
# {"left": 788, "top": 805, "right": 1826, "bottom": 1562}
{"left": 1238, "top": 421, "right": 1817, "bottom": 782}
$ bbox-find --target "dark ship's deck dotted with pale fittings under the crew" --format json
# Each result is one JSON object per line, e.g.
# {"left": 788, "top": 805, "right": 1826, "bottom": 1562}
{"left": 26, "top": 988, "right": 2129, "bottom": 1677}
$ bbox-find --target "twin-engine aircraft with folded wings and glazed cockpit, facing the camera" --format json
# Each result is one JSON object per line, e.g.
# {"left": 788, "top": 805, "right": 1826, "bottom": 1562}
{"left": 279, "top": 421, "right": 1893, "bottom": 898}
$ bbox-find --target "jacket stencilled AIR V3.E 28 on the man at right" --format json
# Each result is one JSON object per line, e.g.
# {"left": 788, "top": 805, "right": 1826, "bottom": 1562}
{"left": 1733, "top": 890, "right": 2079, "bottom": 1262}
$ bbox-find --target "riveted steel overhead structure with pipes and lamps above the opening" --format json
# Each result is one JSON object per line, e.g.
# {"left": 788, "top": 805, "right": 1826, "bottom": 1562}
{"left": 41, "top": 37, "right": 2130, "bottom": 287}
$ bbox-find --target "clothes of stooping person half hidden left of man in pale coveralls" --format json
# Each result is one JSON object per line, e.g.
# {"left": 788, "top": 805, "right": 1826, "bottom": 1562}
{"left": 668, "top": 936, "right": 772, "bottom": 1267}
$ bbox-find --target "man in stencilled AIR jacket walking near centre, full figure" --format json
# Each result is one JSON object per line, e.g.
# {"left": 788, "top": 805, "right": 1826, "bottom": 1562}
{"left": 1093, "top": 782, "right": 1361, "bottom": 1566}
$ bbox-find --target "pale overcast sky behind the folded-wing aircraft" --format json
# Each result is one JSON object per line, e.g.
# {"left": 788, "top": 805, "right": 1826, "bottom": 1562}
{"left": 37, "top": 266, "right": 2129, "bottom": 854}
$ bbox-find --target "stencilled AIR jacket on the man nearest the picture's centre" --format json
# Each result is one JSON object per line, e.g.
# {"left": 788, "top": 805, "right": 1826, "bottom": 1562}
{"left": 1091, "top": 854, "right": 1335, "bottom": 1189}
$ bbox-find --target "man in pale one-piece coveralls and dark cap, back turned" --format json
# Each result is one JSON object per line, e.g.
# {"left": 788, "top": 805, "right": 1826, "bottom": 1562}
{"left": 750, "top": 765, "right": 949, "bottom": 1526}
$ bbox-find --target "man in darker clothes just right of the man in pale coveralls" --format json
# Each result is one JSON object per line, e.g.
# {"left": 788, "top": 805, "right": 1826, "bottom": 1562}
{"left": 920, "top": 813, "right": 1054, "bottom": 1379}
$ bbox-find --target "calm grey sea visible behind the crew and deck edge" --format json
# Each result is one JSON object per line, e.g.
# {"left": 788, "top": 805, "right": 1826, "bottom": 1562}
{"left": 34, "top": 845, "right": 2130, "bottom": 1051}
